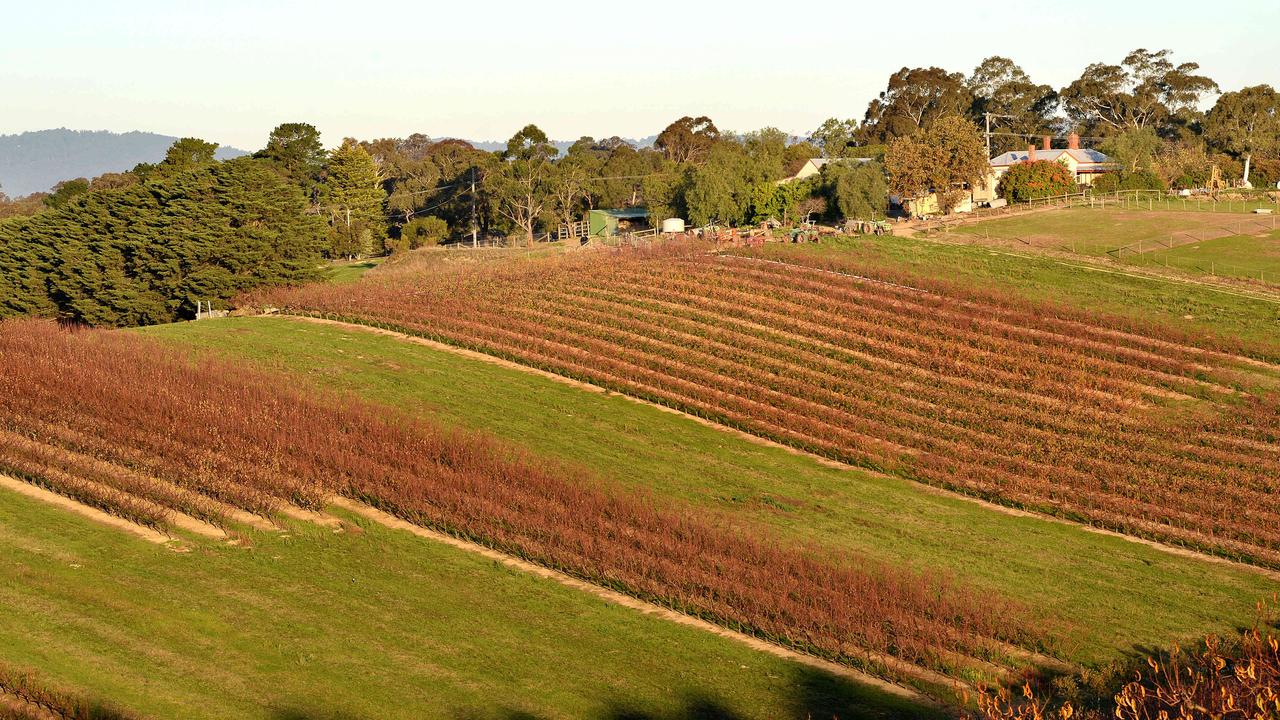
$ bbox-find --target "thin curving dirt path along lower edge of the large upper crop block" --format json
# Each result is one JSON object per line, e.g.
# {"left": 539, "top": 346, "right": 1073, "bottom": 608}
{"left": 275, "top": 314, "right": 1280, "bottom": 580}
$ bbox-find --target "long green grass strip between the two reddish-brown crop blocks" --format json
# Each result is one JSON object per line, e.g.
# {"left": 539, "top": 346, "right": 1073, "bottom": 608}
{"left": 141, "top": 318, "right": 1275, "bottom": 664}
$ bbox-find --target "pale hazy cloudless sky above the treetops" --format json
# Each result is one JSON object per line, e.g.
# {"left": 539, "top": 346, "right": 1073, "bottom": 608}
{"left": 0, "top": 0, "right": 1280, "bottom": 150}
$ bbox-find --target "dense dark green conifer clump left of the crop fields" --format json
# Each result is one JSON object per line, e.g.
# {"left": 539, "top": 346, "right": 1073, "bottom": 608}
{"left": 0, "top": 140, "right": 324, "bottom": 325}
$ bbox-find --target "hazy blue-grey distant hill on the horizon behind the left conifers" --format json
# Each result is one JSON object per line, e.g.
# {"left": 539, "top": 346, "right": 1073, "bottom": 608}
{"left": 0, "top": 128, "right": 247, "bottom": 197}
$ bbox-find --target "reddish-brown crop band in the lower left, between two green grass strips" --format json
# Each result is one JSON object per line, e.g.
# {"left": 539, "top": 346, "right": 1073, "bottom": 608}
{"left": 0, "top": 322, "right": 1041, "bottom": 674}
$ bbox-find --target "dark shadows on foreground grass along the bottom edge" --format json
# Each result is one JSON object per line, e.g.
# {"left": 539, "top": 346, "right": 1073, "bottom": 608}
{"left": 274, "top": 667, "right": 946, "bottom": 720}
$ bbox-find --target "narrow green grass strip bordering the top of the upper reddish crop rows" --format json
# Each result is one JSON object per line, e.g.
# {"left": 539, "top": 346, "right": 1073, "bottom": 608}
{"left": 747, "top": 233, "right": 1280, "bottom": 359}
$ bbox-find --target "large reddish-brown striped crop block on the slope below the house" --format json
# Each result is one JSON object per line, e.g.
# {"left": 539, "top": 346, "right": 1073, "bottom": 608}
{"left": 253, "top": 240, "right": 1280, "bottom": 566}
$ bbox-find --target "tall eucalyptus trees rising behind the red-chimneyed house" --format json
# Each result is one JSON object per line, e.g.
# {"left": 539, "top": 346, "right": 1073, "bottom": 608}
{"left": 810, "top": 49, "right": 1280, "bottom": 187}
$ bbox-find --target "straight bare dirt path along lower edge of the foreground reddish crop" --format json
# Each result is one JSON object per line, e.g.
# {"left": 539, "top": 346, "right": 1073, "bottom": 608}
{"left": 330, "top": 496, "right": 936, "bottom": 705}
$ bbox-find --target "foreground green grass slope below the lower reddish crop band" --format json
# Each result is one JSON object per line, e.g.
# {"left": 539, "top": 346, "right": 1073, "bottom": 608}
{"left": 0, "top": 481, "right": 932, "bottom": 720}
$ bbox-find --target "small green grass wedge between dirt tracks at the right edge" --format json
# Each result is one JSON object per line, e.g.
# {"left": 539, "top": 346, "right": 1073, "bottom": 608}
{"left": 1128, "top": 231, "right": 1280, "bottom": 280}
